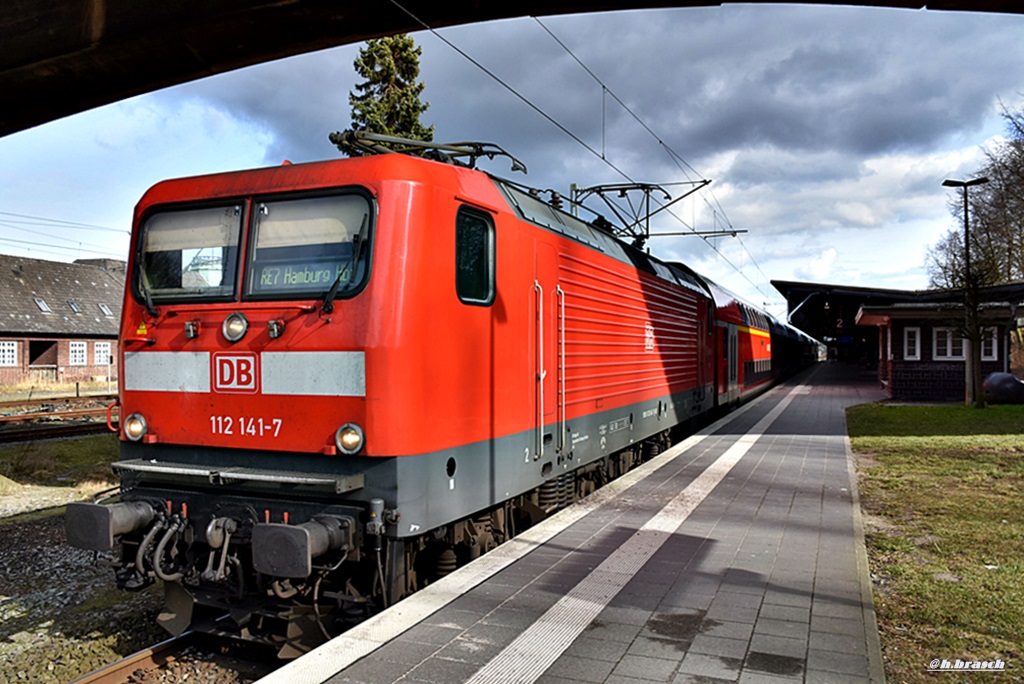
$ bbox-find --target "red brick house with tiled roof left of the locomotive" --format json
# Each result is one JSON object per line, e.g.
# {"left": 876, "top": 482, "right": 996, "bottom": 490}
{"left": 0, "top": 255, "right": 125, "bottom": 387}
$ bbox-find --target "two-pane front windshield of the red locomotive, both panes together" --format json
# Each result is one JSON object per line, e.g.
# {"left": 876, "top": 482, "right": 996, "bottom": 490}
{"left": 135, "top": 188, "right": 371, "bottom": 305}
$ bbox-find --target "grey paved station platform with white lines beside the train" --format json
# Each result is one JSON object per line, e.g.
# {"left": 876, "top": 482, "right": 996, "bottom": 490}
{"left": 261, "top": 365, "right": 884, "bottom": 684}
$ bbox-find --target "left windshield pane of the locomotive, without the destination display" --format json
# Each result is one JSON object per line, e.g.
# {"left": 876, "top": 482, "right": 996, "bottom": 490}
{"left": 137, "top": 205, "right": 242, "bottom": 301}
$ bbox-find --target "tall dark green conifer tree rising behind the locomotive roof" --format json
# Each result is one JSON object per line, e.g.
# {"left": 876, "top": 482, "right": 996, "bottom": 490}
{"left": 331, "top": 34, "right": 434, "bottom": 152}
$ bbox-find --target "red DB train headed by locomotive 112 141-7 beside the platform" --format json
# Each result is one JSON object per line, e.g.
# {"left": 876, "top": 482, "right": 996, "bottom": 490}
{"left": 67, "top": 132, "right": 815, "bottom": 655}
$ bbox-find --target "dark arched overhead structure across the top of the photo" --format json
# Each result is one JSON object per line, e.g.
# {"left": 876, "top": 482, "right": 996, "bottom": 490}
{"left": 6, "top": 0, "right": 1024, "bottom": 136}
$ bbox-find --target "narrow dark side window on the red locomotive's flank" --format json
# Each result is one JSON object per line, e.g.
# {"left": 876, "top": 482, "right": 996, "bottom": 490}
{"left": 455, "top": 207, "right": 495, "bottom": 306}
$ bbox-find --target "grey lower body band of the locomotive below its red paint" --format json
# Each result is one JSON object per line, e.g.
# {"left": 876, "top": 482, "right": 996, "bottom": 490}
{"left": 114, "top": 385, "right": 715, "bottom": 538}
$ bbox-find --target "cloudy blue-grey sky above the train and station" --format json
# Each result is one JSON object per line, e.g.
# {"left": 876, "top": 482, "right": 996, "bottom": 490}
{"left": 0, "top": 5, "right": 1024, "bottom": 313}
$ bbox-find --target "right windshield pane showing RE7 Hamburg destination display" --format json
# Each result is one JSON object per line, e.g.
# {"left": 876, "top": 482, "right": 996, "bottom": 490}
{"left": 246, "top": 194, "right": 370, "bottom": 298}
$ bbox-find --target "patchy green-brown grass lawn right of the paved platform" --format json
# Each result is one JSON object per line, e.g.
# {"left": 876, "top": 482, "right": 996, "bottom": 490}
{"left": 847, "top": 404, "right": 1024, "bottom": 682}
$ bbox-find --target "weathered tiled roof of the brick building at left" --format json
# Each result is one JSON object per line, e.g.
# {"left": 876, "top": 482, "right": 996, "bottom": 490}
{"left": 0, "top": 255, "right": 125, "bottom": 337}
